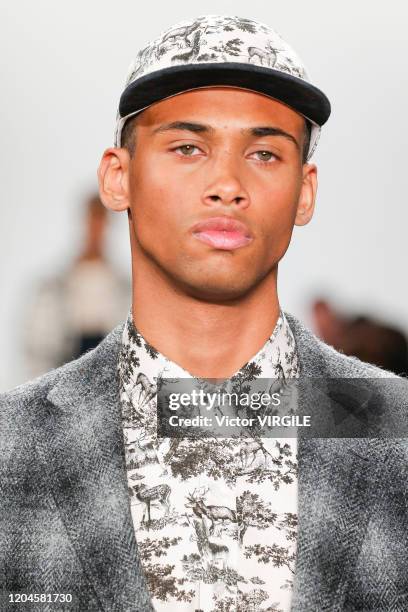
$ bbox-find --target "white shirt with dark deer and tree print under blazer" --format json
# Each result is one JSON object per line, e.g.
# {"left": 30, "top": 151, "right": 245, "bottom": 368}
{"left": 118, "top": 311, "right": 299, "bottom": 612}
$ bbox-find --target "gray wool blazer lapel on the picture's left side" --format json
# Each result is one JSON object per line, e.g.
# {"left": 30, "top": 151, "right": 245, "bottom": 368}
{"left": 39, "top": 326, "right": 152, "bottom": 612}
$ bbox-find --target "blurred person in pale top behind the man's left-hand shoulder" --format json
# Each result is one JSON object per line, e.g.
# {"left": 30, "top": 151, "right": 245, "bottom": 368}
{"left": 24, "top": 194, "right": 130, "bottom": 377}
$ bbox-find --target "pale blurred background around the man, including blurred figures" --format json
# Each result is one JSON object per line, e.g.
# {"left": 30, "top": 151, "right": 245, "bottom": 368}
{"left": 0, "top": 0, "right": 408, "bottom": 391}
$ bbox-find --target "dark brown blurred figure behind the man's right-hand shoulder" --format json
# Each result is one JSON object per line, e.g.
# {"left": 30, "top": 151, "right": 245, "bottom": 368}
{"left": 312, "top": 299, "right": 408, "bottom": 376}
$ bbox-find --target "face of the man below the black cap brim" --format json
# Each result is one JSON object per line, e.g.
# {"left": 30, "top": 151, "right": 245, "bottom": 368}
{"left": 124, "top": 88, "right": 312, "bottom": 301}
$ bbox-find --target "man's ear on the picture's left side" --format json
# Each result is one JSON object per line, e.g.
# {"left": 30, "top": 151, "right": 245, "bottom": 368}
{"left": 98, "top": 147, "right": 130, "bottom": 211}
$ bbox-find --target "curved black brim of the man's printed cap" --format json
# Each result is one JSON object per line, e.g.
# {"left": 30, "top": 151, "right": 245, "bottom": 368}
{"left": 119, "top": 62, "right": 331, "bottom": 126}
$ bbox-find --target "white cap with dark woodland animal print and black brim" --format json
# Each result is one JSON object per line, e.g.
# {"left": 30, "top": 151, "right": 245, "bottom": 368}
{"left": 115, "top": 15, "right": 330, "bottom": 160}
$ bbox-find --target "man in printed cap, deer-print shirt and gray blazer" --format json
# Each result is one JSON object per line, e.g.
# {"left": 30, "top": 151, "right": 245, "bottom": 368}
{"left": 1, "top": 16, "right": 408, "bottom": 612}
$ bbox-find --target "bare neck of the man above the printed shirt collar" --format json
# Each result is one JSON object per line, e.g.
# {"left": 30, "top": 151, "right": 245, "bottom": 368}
{"left": 132, "top": 253, "right": 280, "bottom": 378}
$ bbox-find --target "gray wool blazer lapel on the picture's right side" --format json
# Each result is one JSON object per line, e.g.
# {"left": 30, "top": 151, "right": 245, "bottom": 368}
{"left": 285, "top": 313, "right": 380, "bottom": 612}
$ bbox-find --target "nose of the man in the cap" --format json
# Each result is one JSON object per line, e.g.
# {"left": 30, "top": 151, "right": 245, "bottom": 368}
{"left": 203, "top": 153, "right": 250, "bottom": 209}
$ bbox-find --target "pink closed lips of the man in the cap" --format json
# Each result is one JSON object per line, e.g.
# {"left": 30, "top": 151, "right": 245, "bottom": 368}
{"left": 192, "top": 217, "right": 252, "bottom": 251}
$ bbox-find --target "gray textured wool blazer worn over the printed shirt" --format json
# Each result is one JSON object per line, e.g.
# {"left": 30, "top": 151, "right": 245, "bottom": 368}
{"left": 0, "top": 313, "right": 408, "bottom": 612}
